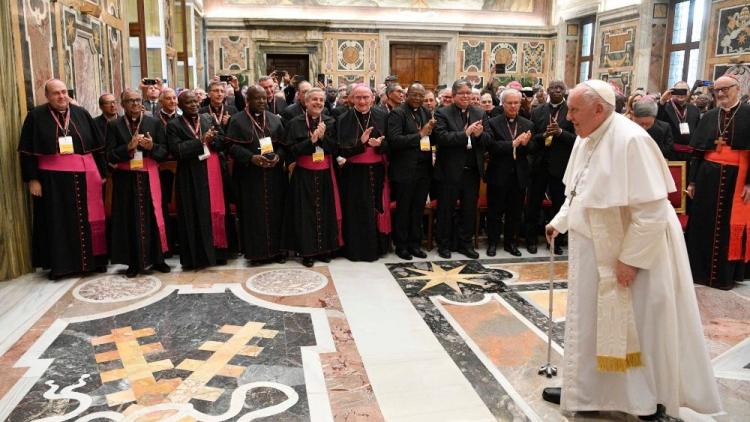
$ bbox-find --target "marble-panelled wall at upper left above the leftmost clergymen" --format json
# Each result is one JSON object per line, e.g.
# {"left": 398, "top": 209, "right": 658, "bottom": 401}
{"left": 10, "top": 0, "right": 127, "bottom": 114}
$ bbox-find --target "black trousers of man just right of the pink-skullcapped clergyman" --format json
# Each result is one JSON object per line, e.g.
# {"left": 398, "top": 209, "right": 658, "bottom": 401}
{"left": 391, "top": 163, "right": 430, "bottom": 248}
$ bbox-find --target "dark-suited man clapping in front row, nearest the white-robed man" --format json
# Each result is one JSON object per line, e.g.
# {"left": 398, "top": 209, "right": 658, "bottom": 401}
{"left": 525, "top": 81, "right": 576, "bottom": 255}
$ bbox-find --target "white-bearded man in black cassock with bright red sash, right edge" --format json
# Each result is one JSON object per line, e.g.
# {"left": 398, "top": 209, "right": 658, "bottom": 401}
{"left": 687, "top": 76, "right": 750, "bottom": 290}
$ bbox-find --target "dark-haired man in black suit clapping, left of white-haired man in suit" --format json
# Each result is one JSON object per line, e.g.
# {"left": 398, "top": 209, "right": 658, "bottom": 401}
{"left": 433, "top": 79, "right": 489, "bottom": 259}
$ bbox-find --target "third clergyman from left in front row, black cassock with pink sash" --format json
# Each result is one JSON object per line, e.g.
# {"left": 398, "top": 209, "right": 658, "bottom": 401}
{"left": 167, "top": 90, "right": 229, "bottom": 270}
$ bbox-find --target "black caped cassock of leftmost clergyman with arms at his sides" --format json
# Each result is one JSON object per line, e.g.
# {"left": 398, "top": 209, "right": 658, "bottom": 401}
{"left": 18, "top": 104, "right": 107, "bottom": 277}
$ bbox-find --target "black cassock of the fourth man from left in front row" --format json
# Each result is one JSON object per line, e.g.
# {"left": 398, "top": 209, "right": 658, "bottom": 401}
{"left": 225, "top": 111, "right": 289, "bottom": 260}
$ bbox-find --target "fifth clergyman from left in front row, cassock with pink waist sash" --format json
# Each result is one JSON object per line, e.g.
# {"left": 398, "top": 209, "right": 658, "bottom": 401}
{"left": 283, "top": 88, "right": 343, "bottom": 267}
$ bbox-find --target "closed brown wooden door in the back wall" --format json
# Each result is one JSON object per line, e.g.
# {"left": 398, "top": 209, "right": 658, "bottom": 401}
{"left": 391, "top": 44, "right": 440, "bottom": 90}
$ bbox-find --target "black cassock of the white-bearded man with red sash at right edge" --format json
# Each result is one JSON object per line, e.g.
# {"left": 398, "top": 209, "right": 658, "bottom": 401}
{"left": 687, "top": 104, "right": 750, "bottom": 290}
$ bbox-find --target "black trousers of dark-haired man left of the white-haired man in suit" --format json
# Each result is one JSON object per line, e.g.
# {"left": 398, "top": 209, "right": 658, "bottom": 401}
{"left": 437, "top": 168, "right": 479, "bottom": 250}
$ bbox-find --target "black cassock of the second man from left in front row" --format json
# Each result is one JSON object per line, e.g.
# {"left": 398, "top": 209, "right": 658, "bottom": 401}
{"left": 107, "top": 116, "right": 167, "bottom": 270}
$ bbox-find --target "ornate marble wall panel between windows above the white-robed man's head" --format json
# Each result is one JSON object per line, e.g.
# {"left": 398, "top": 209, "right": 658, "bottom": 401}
{"left": 592, "top": 17, "right": 639, "bottom": 95}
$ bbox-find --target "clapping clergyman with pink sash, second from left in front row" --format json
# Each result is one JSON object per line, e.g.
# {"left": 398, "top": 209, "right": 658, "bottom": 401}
{"left": 107, "top": 89, "right": 170, "bottom": 278}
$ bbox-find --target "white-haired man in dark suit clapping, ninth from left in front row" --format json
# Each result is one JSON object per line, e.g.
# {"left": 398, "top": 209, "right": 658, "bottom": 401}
{"left": 485, "top": 88, "right": 533, "bottom": 256}
